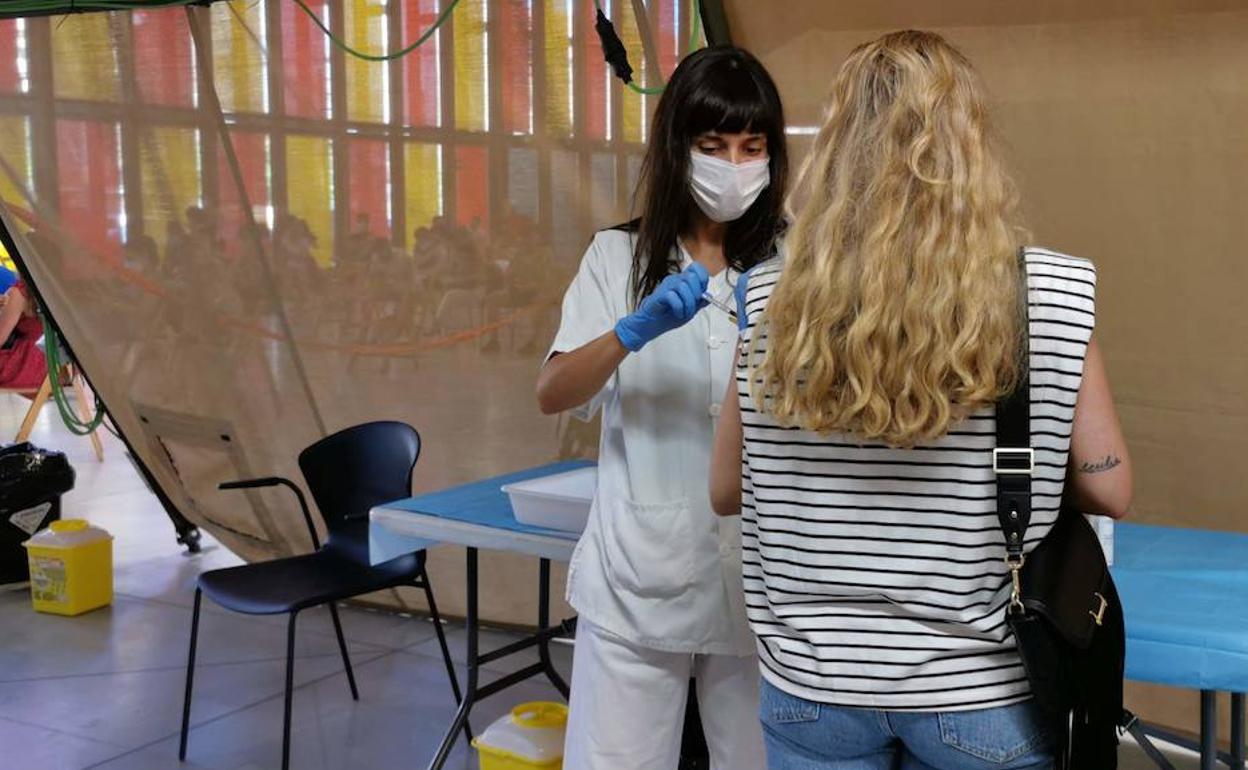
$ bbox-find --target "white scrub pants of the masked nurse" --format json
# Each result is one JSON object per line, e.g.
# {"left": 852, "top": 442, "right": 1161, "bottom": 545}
{"left": 563, "top": 618, "right": 766, "bottom": 770}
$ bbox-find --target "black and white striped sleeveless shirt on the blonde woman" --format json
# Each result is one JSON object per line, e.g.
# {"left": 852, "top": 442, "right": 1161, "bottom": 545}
{"left": 738, "top": 248, "right": 1096, "bottom": 711}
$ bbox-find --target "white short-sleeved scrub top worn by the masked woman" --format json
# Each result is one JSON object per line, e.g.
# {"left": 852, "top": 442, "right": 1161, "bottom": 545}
{"left": 550, "top": 230, "right": 755, "bottom": 655}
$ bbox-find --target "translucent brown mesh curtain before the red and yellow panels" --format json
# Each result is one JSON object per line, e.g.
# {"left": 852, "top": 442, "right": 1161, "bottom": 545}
{"left": 0, "top": 0, "right": 691, "bottom": 616}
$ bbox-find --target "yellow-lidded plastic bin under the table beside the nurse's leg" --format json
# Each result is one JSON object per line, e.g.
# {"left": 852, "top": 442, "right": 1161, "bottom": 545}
{"left": 472, "top": 701, "right": 568, "bottom": 770}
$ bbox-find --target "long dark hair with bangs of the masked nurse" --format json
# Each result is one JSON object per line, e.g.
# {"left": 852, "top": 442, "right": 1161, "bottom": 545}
{"left": 630, "top": 46, "right": 789, "bottom": 305}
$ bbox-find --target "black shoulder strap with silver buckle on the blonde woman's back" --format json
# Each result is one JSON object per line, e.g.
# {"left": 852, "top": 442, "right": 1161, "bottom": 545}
{"left": 992, "top": 248, "right": 1036, "bottom": 591}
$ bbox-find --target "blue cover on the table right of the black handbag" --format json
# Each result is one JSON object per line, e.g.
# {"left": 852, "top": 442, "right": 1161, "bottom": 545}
{"left": 1113, "top": 524, "right": 1248, "bottom": 693}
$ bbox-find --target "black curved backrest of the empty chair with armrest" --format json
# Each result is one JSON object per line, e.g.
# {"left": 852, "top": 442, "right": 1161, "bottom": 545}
{"left": 300, "top": 421, "right": 421, "bottom": 549}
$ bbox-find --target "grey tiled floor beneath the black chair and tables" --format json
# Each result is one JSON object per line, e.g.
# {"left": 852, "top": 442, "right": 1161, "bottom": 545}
{"left": 0, "top": 396, "right": 1197, "bottom": 770}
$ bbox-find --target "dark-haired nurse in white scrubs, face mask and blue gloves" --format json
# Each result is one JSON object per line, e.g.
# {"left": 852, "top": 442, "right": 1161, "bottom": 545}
{"left": 537, "top": 47, "right": 787, "bottom": 770}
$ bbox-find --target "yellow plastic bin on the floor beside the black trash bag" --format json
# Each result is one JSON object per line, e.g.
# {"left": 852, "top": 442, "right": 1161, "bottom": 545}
{"left": 22, "top": 519, "right": 112, "bottom": 615}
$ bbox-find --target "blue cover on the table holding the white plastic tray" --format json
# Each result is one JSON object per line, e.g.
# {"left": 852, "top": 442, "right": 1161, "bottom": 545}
{"left": 368, "top": 461, "right": 594, "bottom": 564}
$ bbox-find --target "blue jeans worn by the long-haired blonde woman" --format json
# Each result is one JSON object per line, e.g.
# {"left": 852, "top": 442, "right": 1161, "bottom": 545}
{"left": 760, "top": 680, "right": 1053, "bottom": 770}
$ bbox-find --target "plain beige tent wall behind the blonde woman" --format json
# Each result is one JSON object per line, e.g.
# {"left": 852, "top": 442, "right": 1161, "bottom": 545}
{"left": 725, "top": 0, "right": 1248, "bottom": 743}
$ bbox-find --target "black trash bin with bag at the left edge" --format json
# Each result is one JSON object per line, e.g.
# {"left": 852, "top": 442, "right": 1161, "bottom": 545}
{"left": 0, "top": 443, "right": 74, "bottom": 584}
